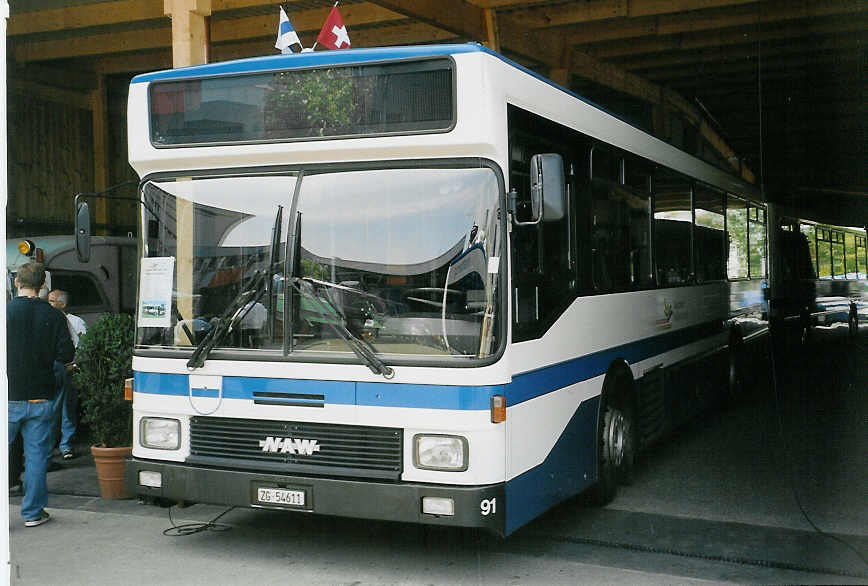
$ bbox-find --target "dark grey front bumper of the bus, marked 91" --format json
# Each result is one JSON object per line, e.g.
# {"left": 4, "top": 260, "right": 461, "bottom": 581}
{"left": 124, "top": 458, "right": 506, "bottom": 535}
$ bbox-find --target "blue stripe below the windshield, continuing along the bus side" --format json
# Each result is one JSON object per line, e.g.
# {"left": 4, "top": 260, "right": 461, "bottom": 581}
{"left": 135, "top": 321, "right": 724, "bottom": 411}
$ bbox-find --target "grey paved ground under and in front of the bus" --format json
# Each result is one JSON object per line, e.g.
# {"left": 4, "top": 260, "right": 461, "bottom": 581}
{"left": 10, "top": 328, "right": 868, "bottom": 585}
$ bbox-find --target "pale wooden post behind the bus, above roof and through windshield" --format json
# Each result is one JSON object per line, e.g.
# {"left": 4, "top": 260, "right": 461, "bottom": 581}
{"left": 163, "top": 0, "right": 211, "bottom": 320}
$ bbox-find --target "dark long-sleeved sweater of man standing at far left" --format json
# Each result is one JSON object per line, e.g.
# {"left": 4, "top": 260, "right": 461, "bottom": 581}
{"left": 6, "top": 297, "right": 75, "bottom": 401}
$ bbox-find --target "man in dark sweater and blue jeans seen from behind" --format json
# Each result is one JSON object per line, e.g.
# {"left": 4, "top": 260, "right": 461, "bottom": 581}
{"left": 6, "top": 263, "right": 74, "bottom": 527}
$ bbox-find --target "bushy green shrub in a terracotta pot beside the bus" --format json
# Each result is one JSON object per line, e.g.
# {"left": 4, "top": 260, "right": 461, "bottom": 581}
{"left": 73, "top": 313, "right": 135, "bottom": 499}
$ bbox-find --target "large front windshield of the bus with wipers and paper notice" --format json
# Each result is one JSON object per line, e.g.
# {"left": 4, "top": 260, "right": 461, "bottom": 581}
{"left": 137, "top": 167, "right": 502, "bottom": 360}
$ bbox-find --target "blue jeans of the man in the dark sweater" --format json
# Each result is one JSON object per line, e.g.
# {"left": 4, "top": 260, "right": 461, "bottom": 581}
{"left": 8, "top": 401, "right": 55, "bottom": 521}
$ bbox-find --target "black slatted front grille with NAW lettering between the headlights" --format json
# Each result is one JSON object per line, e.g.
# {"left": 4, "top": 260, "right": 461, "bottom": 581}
{"left": 187, "top": 417, "right": 403, "bottom": 480}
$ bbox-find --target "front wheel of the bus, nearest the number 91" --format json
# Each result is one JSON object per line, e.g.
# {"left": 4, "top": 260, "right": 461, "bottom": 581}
{"left": 594, "top": 405, "right": 635, "bottom": 505}
